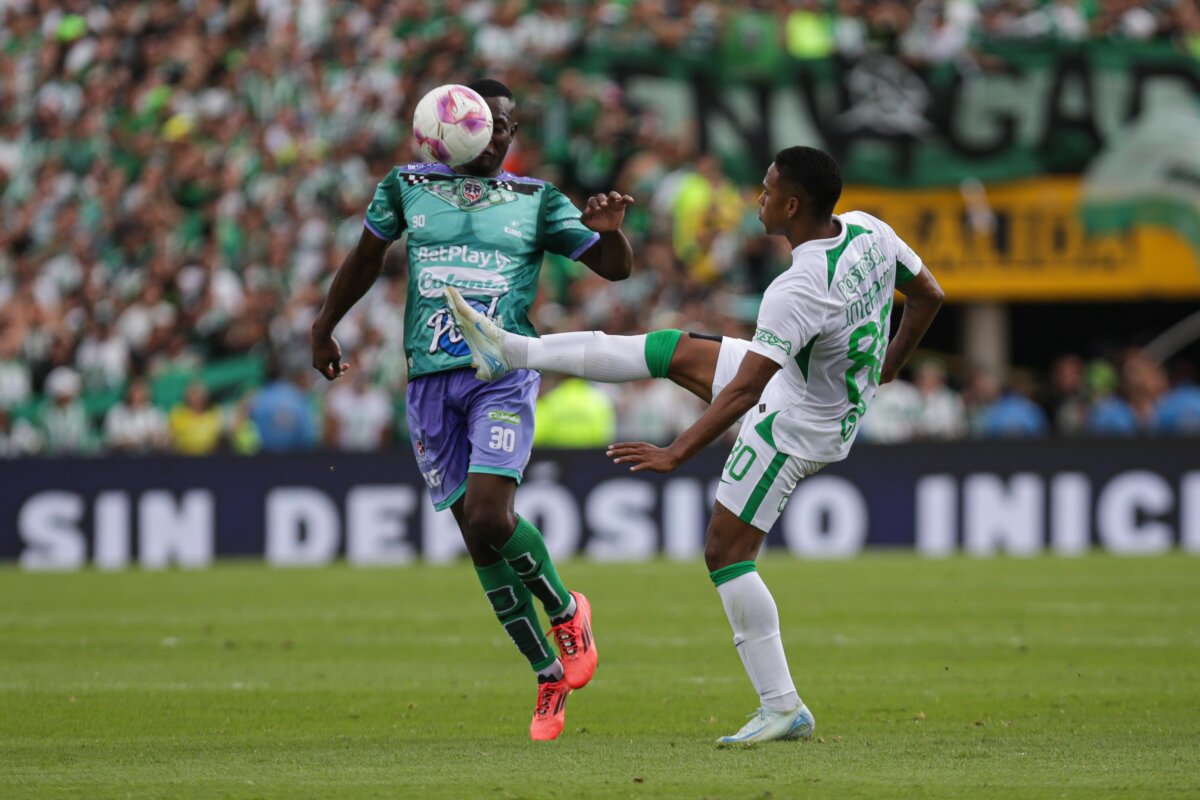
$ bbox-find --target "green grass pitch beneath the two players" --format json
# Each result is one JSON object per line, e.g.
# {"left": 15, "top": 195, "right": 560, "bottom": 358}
{"left": 0, "top": 555, "right": 1200, "bottom": 799}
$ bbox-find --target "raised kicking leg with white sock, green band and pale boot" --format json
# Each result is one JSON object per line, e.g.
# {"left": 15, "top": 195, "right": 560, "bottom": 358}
{"left": 445, "top": 287, "right": 700, "bottom": 401}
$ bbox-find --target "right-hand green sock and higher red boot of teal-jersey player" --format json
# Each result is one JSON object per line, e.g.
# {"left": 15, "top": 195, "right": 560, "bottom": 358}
{"left": 499, "top": 517, "right": 600, "bottom": 688}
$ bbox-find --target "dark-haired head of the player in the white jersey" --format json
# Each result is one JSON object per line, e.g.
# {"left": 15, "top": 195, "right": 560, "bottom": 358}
{"left": 758, "top": 148, "right": 841, "bottom": 234}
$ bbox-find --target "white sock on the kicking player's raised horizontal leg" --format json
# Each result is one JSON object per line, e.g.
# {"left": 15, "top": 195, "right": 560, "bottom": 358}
{"left": 504, "top": 331, "right": 650, "bottom": 384}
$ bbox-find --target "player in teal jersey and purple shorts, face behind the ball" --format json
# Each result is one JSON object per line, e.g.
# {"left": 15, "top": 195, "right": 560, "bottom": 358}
{"left": 312, "top": 80, "right": 634, "bottom": 740}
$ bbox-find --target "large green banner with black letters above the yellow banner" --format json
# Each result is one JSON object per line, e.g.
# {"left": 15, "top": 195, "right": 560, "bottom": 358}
{"left": 584, "top": 42, "right": 1200, "bottom": 187}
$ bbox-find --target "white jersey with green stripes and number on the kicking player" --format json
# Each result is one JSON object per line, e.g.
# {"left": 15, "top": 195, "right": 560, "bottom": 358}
{"left": 750, "top": 211, "right": 924, "bottom": 462}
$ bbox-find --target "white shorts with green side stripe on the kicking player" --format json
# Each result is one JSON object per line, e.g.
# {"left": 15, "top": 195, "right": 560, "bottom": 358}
{"left": 713, "top": 337, "right": 828, "bottom": 533}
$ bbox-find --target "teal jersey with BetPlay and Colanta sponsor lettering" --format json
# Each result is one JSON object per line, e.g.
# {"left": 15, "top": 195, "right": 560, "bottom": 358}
{"left": 366, "top": 163, "right": 600, "bottom": 378}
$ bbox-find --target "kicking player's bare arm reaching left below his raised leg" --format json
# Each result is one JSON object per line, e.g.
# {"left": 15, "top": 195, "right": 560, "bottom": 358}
{"left": 607, "top": 353, "right": 779, "bottom": 473}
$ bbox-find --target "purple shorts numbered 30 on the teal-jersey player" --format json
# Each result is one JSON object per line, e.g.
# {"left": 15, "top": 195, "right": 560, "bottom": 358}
{"left": 408, "top": 369, "right": 541, "bottom": 511}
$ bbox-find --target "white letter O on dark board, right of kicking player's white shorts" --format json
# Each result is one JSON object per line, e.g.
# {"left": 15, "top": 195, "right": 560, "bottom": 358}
{"left": 784, "top": 475, "right": 869, "bottom": 558}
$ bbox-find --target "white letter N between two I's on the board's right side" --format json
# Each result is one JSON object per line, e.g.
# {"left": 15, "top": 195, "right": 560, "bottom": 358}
{"left": 962, "top": 473, "right": 1045, "bottom": 555}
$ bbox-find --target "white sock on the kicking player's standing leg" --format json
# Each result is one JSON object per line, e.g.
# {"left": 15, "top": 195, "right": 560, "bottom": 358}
{"left": 716, "top": 572, "right": 800, "bottom": 711}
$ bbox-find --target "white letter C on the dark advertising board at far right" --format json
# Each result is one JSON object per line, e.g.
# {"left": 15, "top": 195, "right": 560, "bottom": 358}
{"left": 1096, "top": 471, "right": 1172, "bottom": 555}
